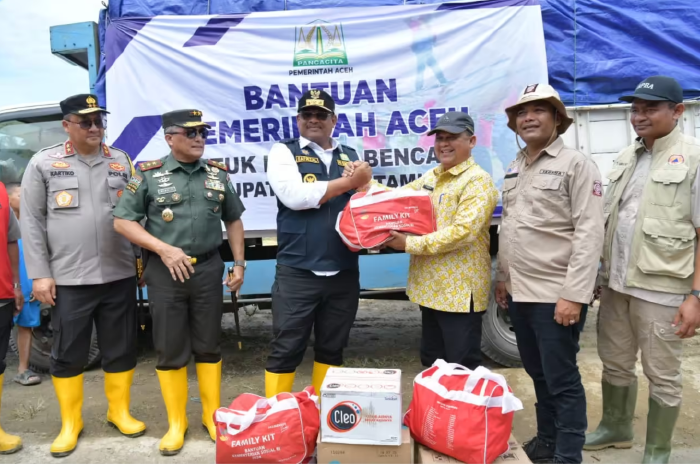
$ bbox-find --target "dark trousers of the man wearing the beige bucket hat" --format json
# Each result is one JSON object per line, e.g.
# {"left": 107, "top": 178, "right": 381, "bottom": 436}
{"left": 508, "top": 296, "right": 588, "bottom": 463}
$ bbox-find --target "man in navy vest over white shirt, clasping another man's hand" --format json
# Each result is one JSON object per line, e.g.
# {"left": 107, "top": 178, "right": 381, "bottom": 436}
{"left": 265, "top": 89, "right": 372, "bottom": 398}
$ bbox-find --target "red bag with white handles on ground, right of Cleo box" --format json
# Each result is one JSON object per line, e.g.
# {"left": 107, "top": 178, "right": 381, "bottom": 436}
{"left": 404, "top": 360, "right": 523, "bottom": 464}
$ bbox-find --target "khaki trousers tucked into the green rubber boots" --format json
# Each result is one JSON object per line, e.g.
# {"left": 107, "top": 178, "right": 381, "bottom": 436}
{"left": 598, "top": 287, "right": 683, "bottom": 407}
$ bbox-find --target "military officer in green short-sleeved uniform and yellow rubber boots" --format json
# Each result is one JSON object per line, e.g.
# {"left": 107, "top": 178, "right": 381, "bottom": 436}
{"left": 114, "top": 110, "right": 245, "bottom": 456}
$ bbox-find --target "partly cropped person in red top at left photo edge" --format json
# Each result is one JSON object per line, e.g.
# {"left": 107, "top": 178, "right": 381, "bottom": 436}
{"left": 0, "top": 178, "right": 24, "bottom": 454}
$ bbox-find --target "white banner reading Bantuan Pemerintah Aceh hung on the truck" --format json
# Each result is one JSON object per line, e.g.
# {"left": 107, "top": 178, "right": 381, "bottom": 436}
{"left": 105, "top": 0, "right": 547, "bottom": 231}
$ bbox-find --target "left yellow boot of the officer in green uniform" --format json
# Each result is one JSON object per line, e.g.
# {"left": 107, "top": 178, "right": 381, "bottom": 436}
{"left": 156, "top": 367, "right": 187, "bottom": 456}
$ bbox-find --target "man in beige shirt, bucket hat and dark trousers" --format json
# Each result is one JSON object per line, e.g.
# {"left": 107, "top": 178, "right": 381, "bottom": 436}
{"left": 496, "top": 84, "right": 603, "bottom": 463}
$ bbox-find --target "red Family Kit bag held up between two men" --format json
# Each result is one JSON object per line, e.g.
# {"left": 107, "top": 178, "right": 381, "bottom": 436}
{"left": 335, "top": 187, "right": 436, "bottom": 251}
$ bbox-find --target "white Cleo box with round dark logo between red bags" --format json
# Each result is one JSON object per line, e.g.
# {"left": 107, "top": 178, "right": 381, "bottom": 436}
{"left": 320, "top": 369, "right": 403, "bottom": 446}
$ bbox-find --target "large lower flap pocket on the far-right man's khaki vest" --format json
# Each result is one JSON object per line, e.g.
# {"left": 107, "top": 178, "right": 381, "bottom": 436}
{"left": 637, "top": 218, "right": 696, "bottom": 279}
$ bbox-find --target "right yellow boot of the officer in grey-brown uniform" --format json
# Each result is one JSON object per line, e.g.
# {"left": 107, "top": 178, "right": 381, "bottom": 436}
{"left": 105, "top": 369, "right": 146, "bottom": 438}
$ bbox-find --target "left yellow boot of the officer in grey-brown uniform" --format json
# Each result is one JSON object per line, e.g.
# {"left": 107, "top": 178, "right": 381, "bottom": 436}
{"left": 51, "top": 374, "right": 83, "bottom": 458}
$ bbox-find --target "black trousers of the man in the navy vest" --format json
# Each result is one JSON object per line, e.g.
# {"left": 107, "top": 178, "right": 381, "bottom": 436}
{"left": 265, "top": 264, "right": 360, "bottom": 374}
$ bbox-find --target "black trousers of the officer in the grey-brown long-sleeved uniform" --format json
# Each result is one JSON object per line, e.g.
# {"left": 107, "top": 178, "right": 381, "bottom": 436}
{"left": 50, "top": 277, "right": 136, "bottom": 378}
